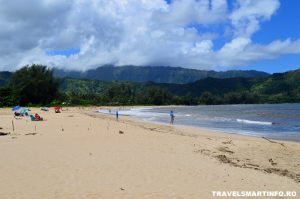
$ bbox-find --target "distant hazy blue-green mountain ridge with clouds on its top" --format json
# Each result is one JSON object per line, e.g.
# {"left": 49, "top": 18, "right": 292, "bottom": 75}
{"left": 54, "top": 65, "right": 270, "bottom": 84}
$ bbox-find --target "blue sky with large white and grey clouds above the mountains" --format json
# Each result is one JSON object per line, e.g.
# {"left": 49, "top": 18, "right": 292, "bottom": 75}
{"left": 0, "top": 0, "right": 300, "bottom": 73}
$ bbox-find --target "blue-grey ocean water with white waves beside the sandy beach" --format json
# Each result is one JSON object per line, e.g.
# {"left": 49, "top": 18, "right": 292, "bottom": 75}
{"left": 100, "top": 104, "right": 300, "bottom": 142}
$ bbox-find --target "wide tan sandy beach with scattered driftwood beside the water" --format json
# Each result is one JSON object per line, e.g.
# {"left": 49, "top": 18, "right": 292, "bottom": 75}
{"left": 0, "top": 107, "right": 300, "bottom": 199}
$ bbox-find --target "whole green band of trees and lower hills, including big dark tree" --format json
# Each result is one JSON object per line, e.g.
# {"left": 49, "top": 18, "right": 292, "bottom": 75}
{"left": 0, "top": 65, "right": 300, "bottom": 107}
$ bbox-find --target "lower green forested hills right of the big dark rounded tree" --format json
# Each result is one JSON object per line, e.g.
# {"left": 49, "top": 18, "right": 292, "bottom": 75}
{"left": 61, "top": 70, "right": 300, "bottom": 105}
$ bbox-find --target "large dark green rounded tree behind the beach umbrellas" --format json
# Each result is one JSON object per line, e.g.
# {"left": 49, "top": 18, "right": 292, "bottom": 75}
{"left": 10, "top": 65, "right": 59, "bottom": 105}
